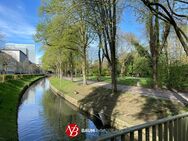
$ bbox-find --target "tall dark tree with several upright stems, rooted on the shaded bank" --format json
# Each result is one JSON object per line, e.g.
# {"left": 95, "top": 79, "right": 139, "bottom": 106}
{"left": 83, "top": 0, "right": 123, "bottom": 93}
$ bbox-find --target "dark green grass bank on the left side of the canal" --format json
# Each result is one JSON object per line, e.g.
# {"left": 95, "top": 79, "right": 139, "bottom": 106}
{"left": 0, "top": 76, "right": 42, "bottom": 141}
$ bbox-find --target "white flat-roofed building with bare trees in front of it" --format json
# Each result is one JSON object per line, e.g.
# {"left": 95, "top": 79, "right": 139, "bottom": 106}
{"left": 0, "top": 48, "right": 42, "bottom": 74}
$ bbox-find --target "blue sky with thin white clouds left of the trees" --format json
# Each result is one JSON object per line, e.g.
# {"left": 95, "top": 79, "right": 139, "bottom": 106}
{"left": 0, "top": 0, "right": 42, "bottom": 62}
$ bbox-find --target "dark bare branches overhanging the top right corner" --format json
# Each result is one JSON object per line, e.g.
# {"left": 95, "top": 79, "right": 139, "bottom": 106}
{"left": 141, "top": 0, "right": 188, "bottom": 55}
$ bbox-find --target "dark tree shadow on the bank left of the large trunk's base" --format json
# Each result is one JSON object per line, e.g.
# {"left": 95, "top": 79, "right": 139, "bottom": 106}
{"left": 79, "top": 87, "right": 123, "bottom": 128}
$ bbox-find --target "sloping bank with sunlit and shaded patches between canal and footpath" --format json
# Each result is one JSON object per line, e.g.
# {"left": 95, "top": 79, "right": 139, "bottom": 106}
{"left": 50, "top": 77, "right": 188, "bottom": 125}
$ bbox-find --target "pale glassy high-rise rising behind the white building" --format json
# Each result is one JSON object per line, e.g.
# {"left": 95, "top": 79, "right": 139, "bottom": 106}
{"left": 5, "top": 43, "right": 36, "bottom": 64}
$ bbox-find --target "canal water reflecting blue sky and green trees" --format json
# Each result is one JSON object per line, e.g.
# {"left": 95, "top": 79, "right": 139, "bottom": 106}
{"left": 18, "top": 78, "right": 104, "bottom": 141}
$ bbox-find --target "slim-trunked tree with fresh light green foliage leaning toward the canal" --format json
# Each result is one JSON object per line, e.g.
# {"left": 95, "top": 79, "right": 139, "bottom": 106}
{"left": 36, "top": 0, "right": 92, "bottom": 85}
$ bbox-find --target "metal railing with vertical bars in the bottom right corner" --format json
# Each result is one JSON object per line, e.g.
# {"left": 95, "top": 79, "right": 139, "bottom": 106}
{"left": 97, "top": 113, "right": 188, "bottom": 141}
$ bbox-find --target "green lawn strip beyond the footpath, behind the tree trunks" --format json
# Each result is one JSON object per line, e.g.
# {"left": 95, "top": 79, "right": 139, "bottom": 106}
{"left": 88, "top": 76, "right": 153, "bottom": 88}
